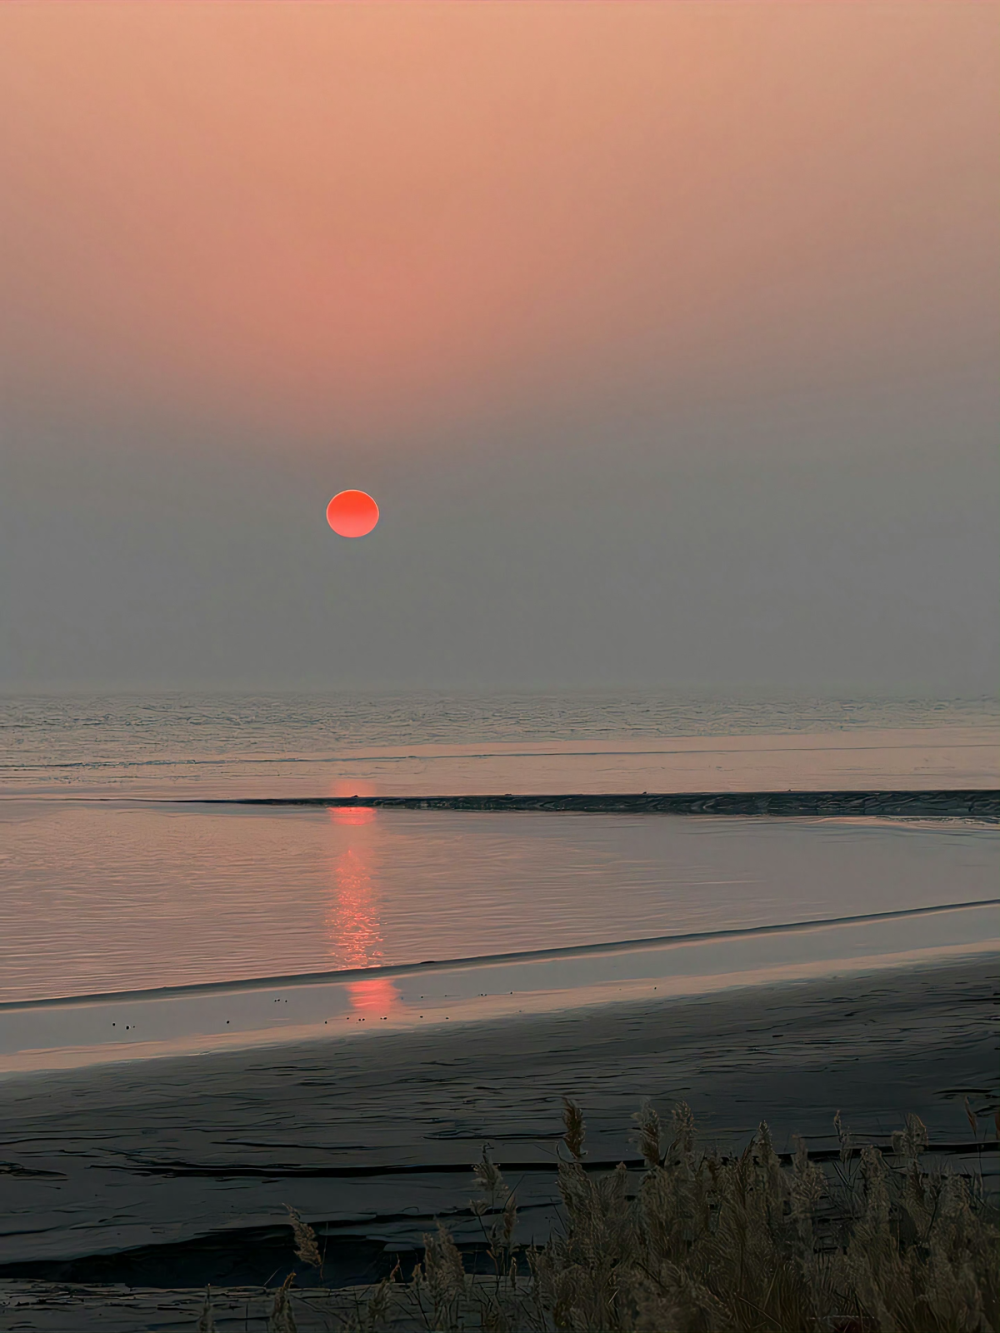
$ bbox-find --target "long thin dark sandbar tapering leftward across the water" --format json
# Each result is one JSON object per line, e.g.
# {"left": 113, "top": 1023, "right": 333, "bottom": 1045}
{"left": 205, "top": 788, "right": 1000, "bottom": 820}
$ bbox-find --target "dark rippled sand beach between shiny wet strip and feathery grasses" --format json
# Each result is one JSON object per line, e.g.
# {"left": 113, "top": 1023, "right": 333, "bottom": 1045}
{"left": 0, "top": 956, "right": 997, "bottom": 1286}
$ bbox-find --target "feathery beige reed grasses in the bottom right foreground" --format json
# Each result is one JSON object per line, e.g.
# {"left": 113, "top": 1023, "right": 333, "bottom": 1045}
{"left": 199, "top": 1101, "right": 1000, "bottom": 1333}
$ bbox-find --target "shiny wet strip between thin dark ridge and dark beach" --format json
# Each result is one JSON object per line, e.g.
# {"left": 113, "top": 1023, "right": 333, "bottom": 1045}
{"left": 0, "top": 898, "right": 1000, "bottom": 1084}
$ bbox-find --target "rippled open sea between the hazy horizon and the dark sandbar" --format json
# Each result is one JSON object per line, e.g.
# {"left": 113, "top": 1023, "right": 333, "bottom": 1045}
{"left": 0, "top": 692, "right": 1000, "bottom": 796}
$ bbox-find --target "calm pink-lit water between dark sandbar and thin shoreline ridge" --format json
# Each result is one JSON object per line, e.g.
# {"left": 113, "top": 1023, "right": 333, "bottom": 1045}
{"left": 0, "top": 801, "right": 997, "bottom": 1000}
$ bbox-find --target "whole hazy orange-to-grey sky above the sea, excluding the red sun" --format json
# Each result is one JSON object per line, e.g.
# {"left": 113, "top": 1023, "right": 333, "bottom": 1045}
{"left": 0, "top": 0, "right": 1000, "bottom": 692}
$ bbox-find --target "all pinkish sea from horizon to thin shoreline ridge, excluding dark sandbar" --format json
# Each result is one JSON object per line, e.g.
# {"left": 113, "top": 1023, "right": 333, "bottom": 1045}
{"left": 0, "top": 692, "right": 1000, "bottom": 1001}
